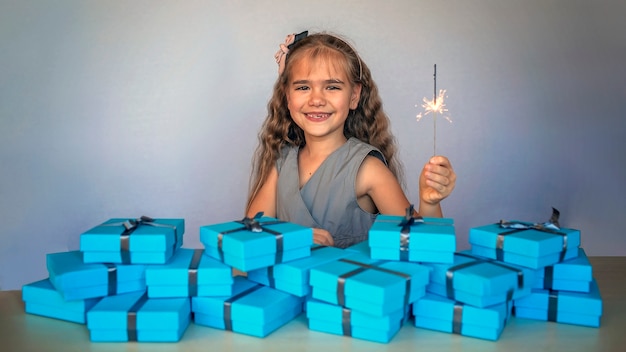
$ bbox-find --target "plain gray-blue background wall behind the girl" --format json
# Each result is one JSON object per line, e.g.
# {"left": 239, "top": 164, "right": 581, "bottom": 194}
{"left": 0, "top": 0, "right": 626, "bottom": 290}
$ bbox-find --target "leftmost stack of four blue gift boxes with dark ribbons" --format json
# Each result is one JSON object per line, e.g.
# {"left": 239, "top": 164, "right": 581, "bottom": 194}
{"left": 22, "top": 217, "right": 191, "bottom": 342}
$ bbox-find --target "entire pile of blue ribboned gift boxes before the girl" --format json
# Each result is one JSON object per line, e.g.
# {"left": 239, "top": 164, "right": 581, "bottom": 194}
{"left": 22, "top": 207, "right": 602, "bottom": 343}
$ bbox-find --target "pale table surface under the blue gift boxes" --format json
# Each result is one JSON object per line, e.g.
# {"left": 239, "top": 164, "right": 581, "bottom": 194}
{"left": 0, "top": 257, "right": 626, "bottom": 352}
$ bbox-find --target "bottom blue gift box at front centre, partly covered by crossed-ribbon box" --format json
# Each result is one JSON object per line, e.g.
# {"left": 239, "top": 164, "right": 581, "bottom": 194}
{"left": 306, "top": 299, "right": 405, "bottom": 343}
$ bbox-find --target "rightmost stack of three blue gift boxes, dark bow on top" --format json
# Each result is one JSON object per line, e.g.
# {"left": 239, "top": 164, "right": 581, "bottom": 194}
{"left": 469, "top": 209, "right": 602, "bottom": 327}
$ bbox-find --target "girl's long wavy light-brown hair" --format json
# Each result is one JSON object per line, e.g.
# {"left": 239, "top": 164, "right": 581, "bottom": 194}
{"left": 246, "top": 33, "right": 404, "bottom": 212}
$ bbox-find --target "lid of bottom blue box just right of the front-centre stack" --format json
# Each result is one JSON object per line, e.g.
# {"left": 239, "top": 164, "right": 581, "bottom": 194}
{"left": 413, "top": 293, "right": 510, "bottom": 330}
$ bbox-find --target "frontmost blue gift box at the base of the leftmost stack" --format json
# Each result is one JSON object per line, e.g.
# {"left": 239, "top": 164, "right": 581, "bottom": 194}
{"left": 87, "top": 292, "right": 191, "bottom": 342}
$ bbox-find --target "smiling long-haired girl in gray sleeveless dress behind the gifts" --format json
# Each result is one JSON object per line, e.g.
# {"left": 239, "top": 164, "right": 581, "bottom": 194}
{"left": 246, "top": 32, "right": 456, "bottom": 248}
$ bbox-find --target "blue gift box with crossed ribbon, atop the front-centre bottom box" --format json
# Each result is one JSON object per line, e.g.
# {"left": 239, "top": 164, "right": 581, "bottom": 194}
{"left": 310, "top": 252, "right": 430, "bottom": 316}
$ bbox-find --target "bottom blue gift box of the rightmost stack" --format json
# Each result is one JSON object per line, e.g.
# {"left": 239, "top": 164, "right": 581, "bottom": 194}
{"left": 514, "top": 280, "right": 602, "bottom": 327}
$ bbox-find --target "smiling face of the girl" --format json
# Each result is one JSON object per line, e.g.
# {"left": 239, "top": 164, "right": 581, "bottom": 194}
{"left": 286, "top": 54, "right": 361, "bottom": 140}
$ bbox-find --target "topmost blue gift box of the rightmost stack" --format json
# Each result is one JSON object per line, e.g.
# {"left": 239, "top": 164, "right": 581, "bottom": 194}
{"left": 469, "top": 224, "right": 580, "bottom": 269}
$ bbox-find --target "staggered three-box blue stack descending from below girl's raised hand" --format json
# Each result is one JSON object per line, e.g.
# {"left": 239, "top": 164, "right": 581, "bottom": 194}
{"left": 361, "top": 207, "right": 516, "bottom": 340}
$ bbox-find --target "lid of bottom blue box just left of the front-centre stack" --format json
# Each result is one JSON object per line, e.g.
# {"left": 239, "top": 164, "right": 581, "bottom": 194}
{"left": 191, "top": 276, "right": 302, "bottom": 325}
